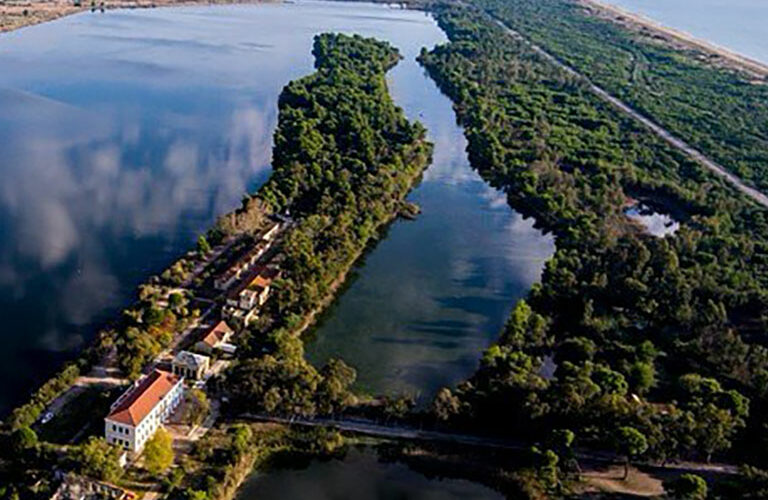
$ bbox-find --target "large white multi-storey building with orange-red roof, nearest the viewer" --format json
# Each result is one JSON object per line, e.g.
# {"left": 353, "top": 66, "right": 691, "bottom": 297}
{"left": 104, "top": 370, "right": 184, "bottom": 453}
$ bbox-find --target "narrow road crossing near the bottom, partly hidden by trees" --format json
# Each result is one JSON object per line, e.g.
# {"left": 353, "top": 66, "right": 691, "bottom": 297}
{"left": 242, "top": 415, "right": 739, "bottom": 474}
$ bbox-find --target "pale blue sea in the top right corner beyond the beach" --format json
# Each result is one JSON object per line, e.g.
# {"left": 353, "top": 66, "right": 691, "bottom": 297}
{"left": 606, "top": 0, "right": 768, "bottom": 64}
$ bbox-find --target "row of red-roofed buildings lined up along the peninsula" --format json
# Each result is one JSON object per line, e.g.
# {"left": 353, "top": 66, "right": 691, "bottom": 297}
{"left": 104, "top": 221, "right": 281, "bottom": 453}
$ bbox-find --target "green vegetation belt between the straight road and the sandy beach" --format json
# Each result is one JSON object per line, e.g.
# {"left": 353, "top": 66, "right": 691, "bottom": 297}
{"left": 472, "top": 0, "right": 768, "bottom": 191}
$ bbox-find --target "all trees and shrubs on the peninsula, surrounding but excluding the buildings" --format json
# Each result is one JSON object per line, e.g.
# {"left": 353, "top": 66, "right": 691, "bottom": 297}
{"left": 0, "top": 35, "right": 431, "bottom": 499}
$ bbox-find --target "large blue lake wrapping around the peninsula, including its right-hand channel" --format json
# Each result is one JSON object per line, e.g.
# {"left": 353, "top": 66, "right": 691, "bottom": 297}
{"left": 0, "top": 2, "right": 553, "bottom": 409}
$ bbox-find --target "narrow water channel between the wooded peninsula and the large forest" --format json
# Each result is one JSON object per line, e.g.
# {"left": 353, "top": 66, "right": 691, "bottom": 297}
{"left": 308, "top": 37, "right": 554, "bottom": 401}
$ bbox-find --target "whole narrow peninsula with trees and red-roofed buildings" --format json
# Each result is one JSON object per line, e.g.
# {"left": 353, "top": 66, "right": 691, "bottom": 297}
{"left": 0, "top": 30, "right": 432, "bottom": 499}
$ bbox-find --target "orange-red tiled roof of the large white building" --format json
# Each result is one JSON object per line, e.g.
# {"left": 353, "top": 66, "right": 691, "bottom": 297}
{"left": 107, "top": 370, "right": 181, "bottom": 426}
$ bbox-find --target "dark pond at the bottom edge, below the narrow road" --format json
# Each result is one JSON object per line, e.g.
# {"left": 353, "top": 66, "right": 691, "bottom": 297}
{"left": 237, "top": 448, "right": 504, "bottom": 500}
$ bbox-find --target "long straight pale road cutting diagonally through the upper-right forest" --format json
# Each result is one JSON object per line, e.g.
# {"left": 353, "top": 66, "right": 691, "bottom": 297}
{"left": 489, "top": 14, "right": 768, "bottom": 208}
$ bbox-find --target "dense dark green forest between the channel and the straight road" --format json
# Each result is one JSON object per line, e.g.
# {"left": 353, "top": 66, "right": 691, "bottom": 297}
{"left": 420, "top": 1, "right": 768, "bottom": 472}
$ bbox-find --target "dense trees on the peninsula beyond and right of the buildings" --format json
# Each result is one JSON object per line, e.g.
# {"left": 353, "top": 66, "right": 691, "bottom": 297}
{"left": 220, "top": 34, "right": 431, "bottom": 416}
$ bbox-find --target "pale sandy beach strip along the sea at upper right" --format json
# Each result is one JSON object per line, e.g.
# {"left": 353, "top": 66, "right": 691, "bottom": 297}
{"left": 577, "top": 0, "right": 768, "bottom": 79}
